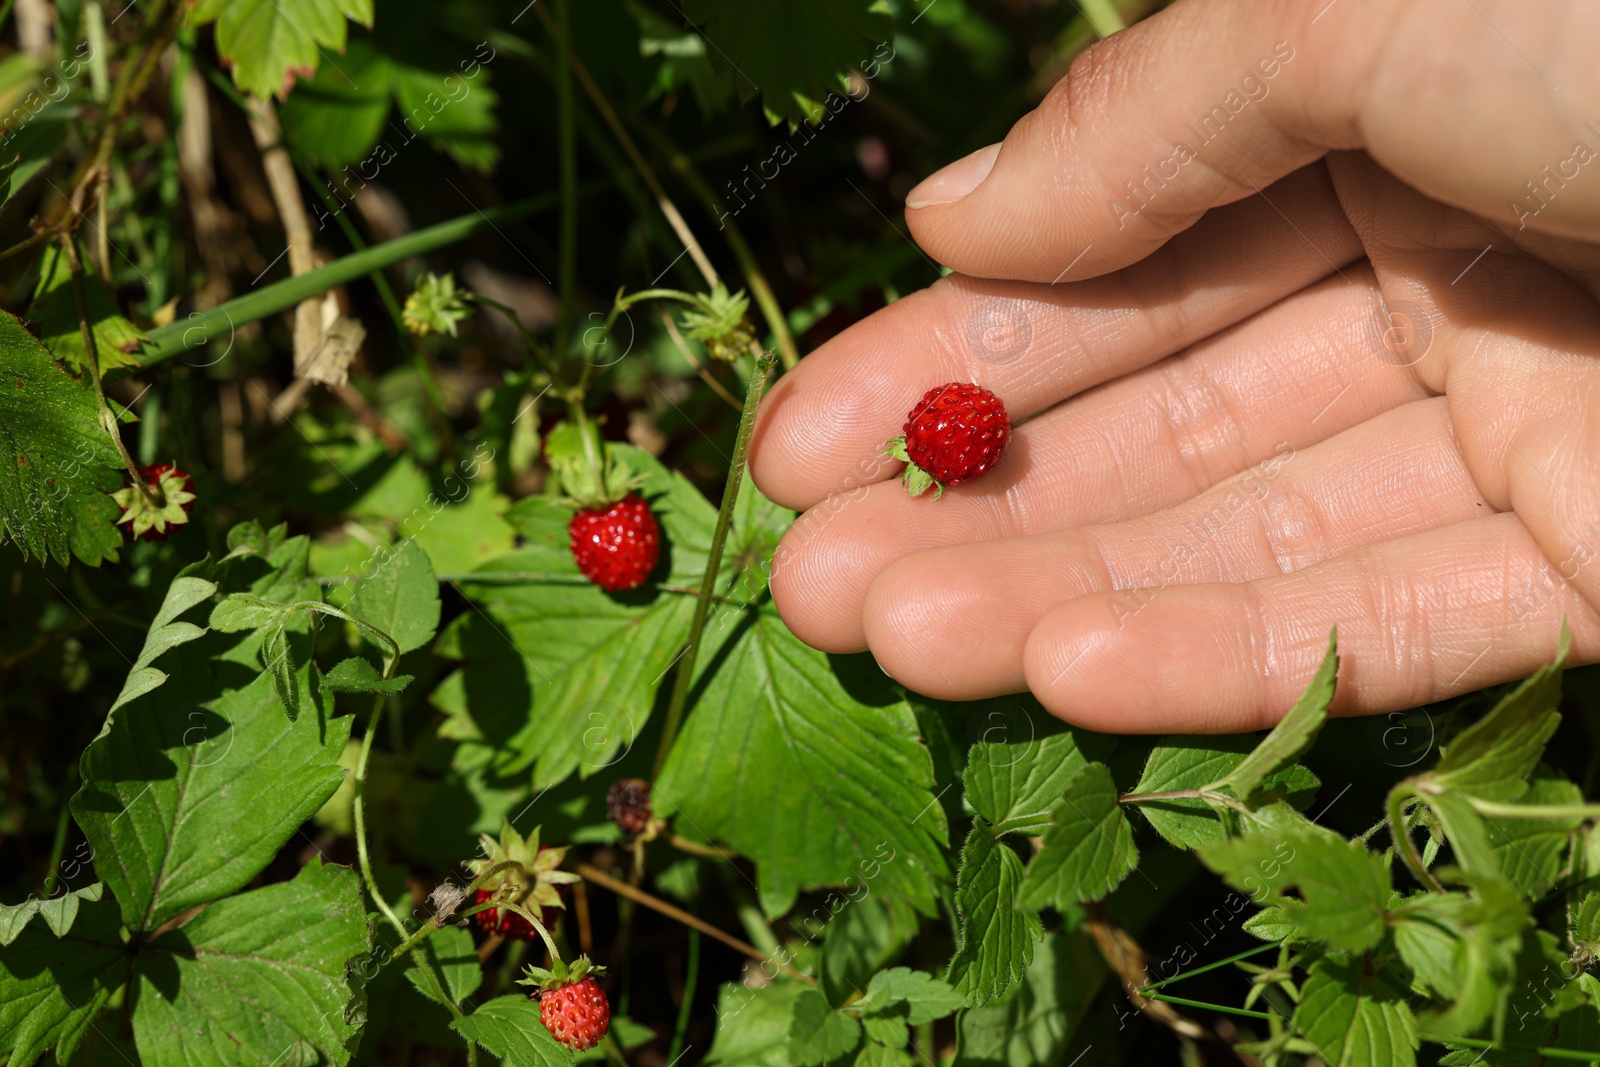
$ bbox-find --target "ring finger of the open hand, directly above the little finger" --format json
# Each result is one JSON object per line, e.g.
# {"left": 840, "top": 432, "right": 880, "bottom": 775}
{"left": 862, "top": 397, "right": 1488, "bottom": 701}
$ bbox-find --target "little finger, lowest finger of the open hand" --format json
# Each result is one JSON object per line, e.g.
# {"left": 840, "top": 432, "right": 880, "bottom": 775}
{"left": 1026, "top": 514, "right": 1600, "bottom": 733}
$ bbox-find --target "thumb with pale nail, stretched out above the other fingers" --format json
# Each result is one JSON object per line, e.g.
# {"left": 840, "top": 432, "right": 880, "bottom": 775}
{"left": 906, "top": 0, "right": 1600, "bottom": 282}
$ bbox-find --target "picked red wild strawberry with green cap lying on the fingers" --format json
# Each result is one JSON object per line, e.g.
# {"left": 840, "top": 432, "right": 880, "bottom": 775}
{"left": 883, "top": 382, "right": 1011, "bottom": 499}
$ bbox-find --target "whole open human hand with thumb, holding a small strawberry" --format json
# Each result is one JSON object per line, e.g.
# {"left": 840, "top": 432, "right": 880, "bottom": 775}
{"left": 750, "top": 0, "right": 1600, "bottom": 733}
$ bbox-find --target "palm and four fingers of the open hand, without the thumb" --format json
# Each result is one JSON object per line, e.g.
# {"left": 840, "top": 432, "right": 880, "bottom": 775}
{"left": 752, "top": 152, "right": 1600, "bottom": 731}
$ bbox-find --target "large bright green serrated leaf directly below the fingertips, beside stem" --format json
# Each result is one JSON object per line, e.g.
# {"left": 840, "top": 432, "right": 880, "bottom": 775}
{"left": 656, "top": 627, "right": 947, "bottom": 915}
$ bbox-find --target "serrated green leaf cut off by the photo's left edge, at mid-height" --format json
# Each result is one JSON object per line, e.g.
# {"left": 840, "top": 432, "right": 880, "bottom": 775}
{"left": 0, "top": 314, "right": 122, "bottom": 566}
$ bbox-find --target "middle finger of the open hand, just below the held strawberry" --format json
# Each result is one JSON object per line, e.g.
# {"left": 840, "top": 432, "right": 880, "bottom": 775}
{"left": 773, "top": 264, "right": 1427, "bottom": 653}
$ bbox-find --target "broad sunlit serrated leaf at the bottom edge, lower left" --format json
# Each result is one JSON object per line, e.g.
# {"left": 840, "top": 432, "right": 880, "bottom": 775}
{"left": 133, "top": 857, "right": 371, "bottom": 1067}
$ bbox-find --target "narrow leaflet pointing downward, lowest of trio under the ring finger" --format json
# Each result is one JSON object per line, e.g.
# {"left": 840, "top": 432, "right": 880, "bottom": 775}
{"left": 944, "top": 819, "right": 1045, "bottom": 1006}
